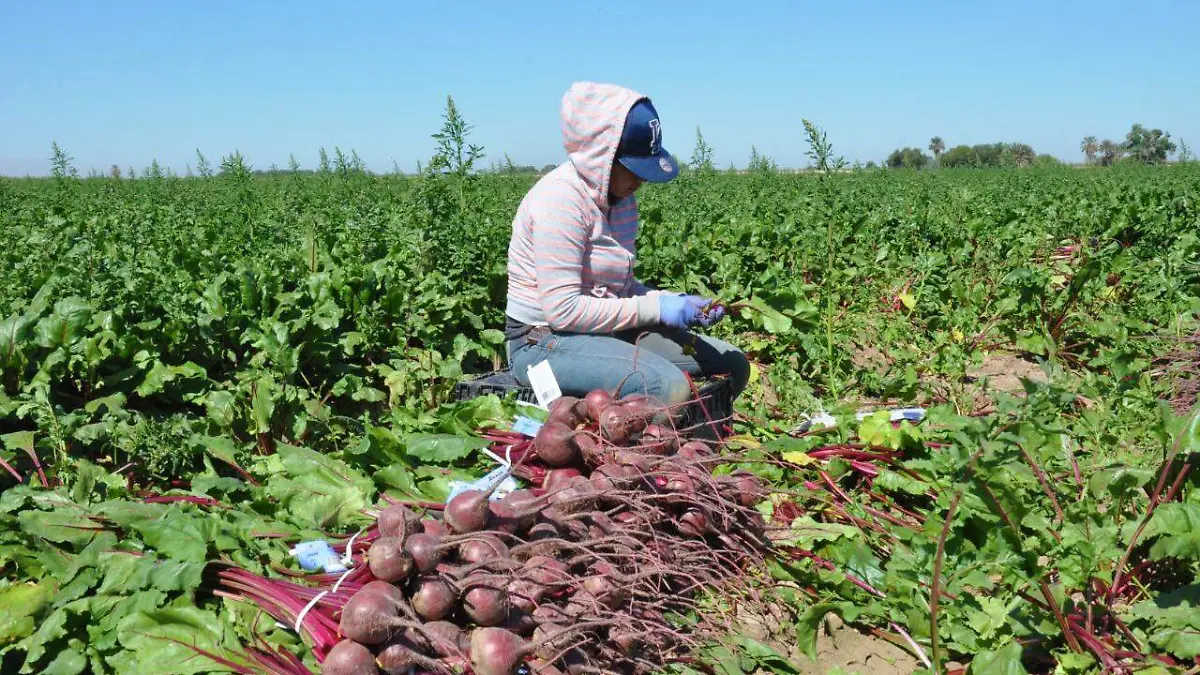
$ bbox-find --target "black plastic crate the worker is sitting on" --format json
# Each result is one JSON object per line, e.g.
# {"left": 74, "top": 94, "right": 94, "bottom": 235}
{"left": 455, "top": 370, "right": 733, "bottom": 441}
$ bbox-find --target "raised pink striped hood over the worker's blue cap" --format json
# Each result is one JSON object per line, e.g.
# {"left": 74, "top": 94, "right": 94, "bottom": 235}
{"left": 559, "top": 82, "right": 647, "bottom": 209}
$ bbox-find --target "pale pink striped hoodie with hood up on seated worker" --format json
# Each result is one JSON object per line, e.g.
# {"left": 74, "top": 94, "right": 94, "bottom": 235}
{"left": 506, "top": 82, "right": 659, "bottom": 333}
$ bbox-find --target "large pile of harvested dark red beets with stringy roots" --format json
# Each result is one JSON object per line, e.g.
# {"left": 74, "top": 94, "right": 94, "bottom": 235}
{"left": 322, "top": 392, "right": 769, "bottom": 675}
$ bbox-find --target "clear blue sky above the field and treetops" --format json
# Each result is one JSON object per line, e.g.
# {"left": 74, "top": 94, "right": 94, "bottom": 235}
{"left": 0, "top": 0, "right": 1200, "bottom": 174}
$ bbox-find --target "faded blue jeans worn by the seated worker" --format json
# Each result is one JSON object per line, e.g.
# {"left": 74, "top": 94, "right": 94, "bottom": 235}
{"left": 508, "top": 327, "right": 750, "bottom": 406}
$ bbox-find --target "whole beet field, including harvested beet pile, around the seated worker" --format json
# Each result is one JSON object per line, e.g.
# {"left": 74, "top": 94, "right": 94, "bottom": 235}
{"left": 0, "top": 155, "right": 1200, "bottom": 675}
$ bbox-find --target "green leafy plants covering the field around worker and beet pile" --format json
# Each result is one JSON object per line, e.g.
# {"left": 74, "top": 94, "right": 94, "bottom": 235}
{"left": 0, "top": 153, "right": 1200, "bottom": 673}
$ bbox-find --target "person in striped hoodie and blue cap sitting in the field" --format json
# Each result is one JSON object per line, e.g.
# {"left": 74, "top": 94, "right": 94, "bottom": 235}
{"left": 505, "top": 78, "right": 750, "bottom": 405}
